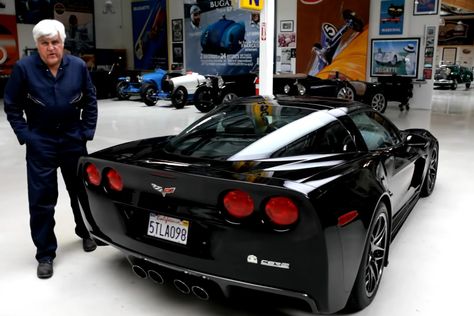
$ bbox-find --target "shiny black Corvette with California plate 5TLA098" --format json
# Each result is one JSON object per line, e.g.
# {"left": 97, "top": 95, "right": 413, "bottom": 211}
{"left": 78, "top": 97, "right": 438, "bottom": 313}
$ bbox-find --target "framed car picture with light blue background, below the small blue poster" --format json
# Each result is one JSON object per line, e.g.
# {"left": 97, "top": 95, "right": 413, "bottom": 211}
{"left": 370, "top": 37, "right": 420, "bottom": 78}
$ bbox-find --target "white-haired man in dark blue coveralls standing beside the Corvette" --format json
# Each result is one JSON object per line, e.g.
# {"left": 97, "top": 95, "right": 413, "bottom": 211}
{"left": 4, "top": 20, "right": 97, "bottom": 279}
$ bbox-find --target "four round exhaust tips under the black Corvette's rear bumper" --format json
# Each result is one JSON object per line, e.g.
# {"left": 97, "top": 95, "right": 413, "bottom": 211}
{"left": 130, "top": 259, "right": 210, "bottom": 301}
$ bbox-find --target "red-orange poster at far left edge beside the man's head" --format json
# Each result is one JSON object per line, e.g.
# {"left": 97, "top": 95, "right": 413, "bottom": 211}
{"left": 0, "top": 14, "right": 20, "bottom": 76}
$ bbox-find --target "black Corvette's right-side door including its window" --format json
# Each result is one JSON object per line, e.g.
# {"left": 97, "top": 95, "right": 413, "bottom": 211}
{"left": 350, "top": 110, "right": 418, "bottom": 214}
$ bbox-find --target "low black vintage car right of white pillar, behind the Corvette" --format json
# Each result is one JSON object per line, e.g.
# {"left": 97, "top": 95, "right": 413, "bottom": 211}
{"left": 273, "top": 74, "right": 387, "bottom": 113}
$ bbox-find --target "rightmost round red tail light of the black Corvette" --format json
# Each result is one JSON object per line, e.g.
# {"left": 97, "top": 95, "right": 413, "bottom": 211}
{"left": 265, "top": 197, "right": 299, "bottom": 226}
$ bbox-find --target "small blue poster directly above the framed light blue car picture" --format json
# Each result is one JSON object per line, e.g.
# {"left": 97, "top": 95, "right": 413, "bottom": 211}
{"left": 379, "top": 0, "right": 405, "bottom": 35}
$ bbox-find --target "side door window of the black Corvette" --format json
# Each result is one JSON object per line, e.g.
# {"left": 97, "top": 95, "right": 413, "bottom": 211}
{"left": 350, "top": 111, "right": 401, "bottom": 150}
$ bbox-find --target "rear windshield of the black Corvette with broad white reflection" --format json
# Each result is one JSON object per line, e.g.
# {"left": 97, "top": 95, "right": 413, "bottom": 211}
{"left": 165, "top": 101, "right": 354, "bottom": 160}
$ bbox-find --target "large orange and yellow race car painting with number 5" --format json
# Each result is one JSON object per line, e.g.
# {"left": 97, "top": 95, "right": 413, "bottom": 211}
{"left": 296, "top": 0, "right": 370, "bottom": 80}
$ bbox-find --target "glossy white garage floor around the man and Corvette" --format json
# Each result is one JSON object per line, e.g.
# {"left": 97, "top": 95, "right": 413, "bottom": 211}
{"left": 0, "top": 88, "right": 474, "bottom": 316}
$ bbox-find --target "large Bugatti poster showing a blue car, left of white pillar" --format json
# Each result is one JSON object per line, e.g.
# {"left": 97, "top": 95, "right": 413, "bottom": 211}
{"left": 184, "top": 0, "right": 260, "bottom": 75}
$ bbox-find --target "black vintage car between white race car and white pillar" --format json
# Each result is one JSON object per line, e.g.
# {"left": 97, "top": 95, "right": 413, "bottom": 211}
{"left": 194, "top": 73, "right": 257, "bottom": 113}
